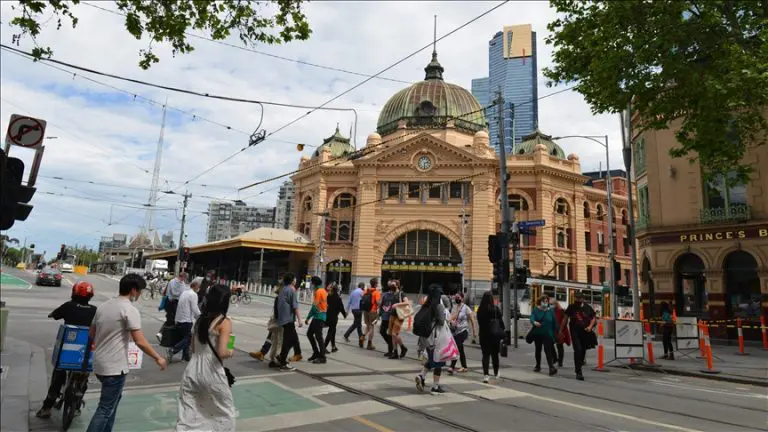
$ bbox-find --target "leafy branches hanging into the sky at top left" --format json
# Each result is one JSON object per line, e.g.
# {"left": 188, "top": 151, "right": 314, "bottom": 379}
{"left": 10, "top": 0, "right": 311, "bottom": 69}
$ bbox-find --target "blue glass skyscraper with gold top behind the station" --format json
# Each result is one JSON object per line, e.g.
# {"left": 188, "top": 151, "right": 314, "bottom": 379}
{"left": 472, "top": 24, "right": 539, "bottom": 154}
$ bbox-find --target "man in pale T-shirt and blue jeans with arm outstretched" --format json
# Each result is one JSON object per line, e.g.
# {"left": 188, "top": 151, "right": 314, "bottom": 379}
{"left": 87, "top": 274, "right": 166, "bottom": 432}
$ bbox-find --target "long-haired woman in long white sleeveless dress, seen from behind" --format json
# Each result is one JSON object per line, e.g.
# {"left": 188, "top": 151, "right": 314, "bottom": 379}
{"left": 176, "top": 285, "right": 235, "bottom": 432}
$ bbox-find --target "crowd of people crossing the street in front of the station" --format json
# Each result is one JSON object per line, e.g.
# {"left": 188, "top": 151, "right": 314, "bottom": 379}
{"left": 37, "top": 272, "right": 608, "bottom": 432}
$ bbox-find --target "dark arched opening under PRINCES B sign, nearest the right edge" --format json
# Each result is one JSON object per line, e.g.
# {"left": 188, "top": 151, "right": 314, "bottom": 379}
{"left": 723, "top": 251, "right": 760, "bottom": 319}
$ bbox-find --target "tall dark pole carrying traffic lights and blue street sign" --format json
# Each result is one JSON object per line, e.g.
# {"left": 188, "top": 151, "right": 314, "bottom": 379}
{"left": 496, "top": 86, "right": 517, "bottom": 346}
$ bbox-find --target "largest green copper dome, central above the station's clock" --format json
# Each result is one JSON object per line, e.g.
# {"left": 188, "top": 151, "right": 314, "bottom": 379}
{"left": 376, "top": 52, "right": 487, "bottom": 135}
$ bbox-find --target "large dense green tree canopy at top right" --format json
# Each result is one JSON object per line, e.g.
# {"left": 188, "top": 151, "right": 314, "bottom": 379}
{"left": 544, "top": 0, "right": 768, "bottom": 181}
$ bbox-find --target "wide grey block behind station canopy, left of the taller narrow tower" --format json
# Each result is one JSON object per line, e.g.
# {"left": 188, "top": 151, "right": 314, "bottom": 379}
{"left": 207, "top": 201, "right": 275, "bottom": 242}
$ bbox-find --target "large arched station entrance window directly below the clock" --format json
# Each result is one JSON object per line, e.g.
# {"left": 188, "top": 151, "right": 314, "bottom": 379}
{"left": 381, "top": 230, "right": 461, "bottom": 294}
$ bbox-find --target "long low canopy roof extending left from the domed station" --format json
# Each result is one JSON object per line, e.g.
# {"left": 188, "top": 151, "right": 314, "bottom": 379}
{"left": 144, "top": 228, "right": 315, "bottom": 259}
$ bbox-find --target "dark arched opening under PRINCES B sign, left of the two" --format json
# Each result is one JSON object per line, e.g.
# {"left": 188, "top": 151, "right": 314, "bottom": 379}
{"left": 675, "top": 252, "right": 707, "bottom": 316}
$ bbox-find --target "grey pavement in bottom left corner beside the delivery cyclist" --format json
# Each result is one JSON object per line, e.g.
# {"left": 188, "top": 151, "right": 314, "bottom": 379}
{"left": 0, "top": 335, "right": 48, "bottom": 432}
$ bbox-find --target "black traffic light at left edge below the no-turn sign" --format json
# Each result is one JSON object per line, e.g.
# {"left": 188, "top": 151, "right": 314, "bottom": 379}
{"left": 0, "top": 149, "right": 36, "bottom": 230}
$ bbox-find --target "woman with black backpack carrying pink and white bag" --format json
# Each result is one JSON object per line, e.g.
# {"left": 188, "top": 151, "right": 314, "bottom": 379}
{"left": 414, "top": 284, "right": 448, "bottom": 394}
